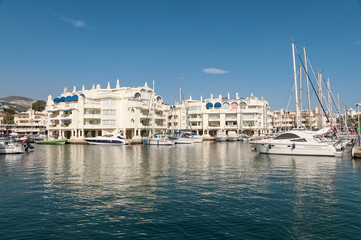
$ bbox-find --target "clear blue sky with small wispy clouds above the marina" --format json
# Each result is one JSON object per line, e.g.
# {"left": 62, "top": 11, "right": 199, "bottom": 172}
{"left": 0, "top": 0, "right": 361, "bottom": 110}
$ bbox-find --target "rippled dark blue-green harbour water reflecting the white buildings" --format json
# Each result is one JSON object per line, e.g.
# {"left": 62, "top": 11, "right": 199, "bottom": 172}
{"left": 0, "top": 142, "right": 361, "bottom": 239}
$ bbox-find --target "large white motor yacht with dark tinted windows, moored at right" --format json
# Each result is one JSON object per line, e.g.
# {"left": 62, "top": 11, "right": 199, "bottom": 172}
{"left": 251, "top": 128, "right": 338, "bottom": 156}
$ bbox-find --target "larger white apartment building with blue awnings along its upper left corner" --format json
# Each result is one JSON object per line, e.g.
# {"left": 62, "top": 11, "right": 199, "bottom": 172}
{"left": 46, "top": 80, "right": 170, "bottom": 139}
